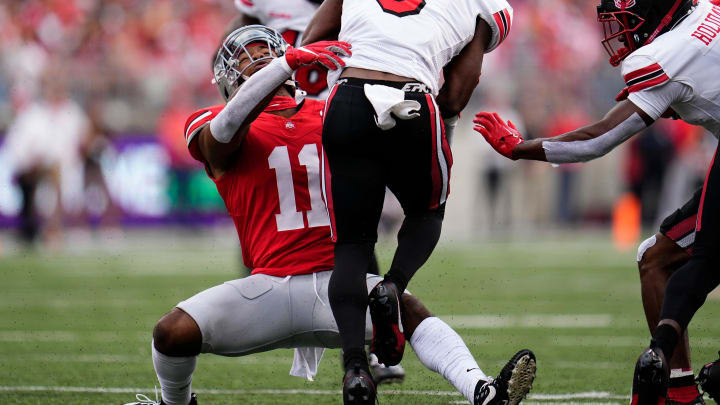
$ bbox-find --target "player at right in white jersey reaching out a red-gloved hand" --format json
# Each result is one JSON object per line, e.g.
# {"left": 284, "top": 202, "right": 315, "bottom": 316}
{"left": 475, "top": 0, "right": 720, "bottom": 405}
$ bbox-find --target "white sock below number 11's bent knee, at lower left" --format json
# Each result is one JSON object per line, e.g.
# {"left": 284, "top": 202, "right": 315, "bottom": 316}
{"left": 152, "top": 342, "right": 197, "bottom": 405}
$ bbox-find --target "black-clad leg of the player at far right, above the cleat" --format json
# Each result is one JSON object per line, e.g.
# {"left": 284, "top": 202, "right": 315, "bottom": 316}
{"left": 660, "top": 142, "right": 720, "bottom": 330}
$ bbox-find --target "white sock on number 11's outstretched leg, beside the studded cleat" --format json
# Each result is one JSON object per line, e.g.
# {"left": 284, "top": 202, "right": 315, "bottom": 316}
{"left": 410, "top": 317, "right": 488, "bottom": 403}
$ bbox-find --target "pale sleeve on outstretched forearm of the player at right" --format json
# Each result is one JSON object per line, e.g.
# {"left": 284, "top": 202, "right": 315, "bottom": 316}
{"left": 542, "top": 113, "right": 647, "bottom": 163}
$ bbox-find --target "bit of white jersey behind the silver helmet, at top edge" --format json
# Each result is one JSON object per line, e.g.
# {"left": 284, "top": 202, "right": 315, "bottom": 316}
{"left": 235, "top": 0, "right": 319, "bottom": 34}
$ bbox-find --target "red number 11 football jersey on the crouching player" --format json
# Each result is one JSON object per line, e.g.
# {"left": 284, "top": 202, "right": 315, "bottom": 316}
{"left": 185, "top": 99, "right": 334, "bottom": 277}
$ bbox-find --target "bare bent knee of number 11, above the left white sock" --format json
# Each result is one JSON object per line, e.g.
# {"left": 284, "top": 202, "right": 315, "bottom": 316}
{"left": 153, "top": 308, "right": 202, "bottom": 357}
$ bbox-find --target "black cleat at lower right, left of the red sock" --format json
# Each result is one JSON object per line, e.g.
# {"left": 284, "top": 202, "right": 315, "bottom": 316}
{"left": 630, "top": 348, "right": 670, "bottom": 405}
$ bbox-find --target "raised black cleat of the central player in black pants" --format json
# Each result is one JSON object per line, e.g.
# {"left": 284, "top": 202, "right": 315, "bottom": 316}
{"left": 368, "top": 280, "right": 405, "bottom": 367}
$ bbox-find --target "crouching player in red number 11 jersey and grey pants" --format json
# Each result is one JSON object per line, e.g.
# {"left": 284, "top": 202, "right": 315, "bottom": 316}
{"left": 124, "top": 25, "right": 535, "bottom": 405}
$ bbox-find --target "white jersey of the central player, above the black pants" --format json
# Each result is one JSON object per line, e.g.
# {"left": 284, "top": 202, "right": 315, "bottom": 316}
{"left": 333, "top": 0, "right": 513, "bottom": 94}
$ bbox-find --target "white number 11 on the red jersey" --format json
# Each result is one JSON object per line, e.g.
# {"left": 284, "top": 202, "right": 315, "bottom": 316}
{"left": 268, "top": 143, "right": 330, "bottom": 232}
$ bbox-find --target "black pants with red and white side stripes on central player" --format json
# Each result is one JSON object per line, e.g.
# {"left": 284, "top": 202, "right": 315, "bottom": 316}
{"left": 322, "top": 78, "right": 452, "bottom": 242}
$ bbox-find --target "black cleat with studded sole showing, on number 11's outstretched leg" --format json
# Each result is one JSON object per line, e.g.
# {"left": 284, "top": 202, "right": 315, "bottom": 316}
{"left": 473, "top": 349, "right": 537, "bottom": 405}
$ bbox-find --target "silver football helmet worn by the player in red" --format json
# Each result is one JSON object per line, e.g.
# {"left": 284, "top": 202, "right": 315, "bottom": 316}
{"left": 213, "top": 25, "right": 288, "bottom": 101}
